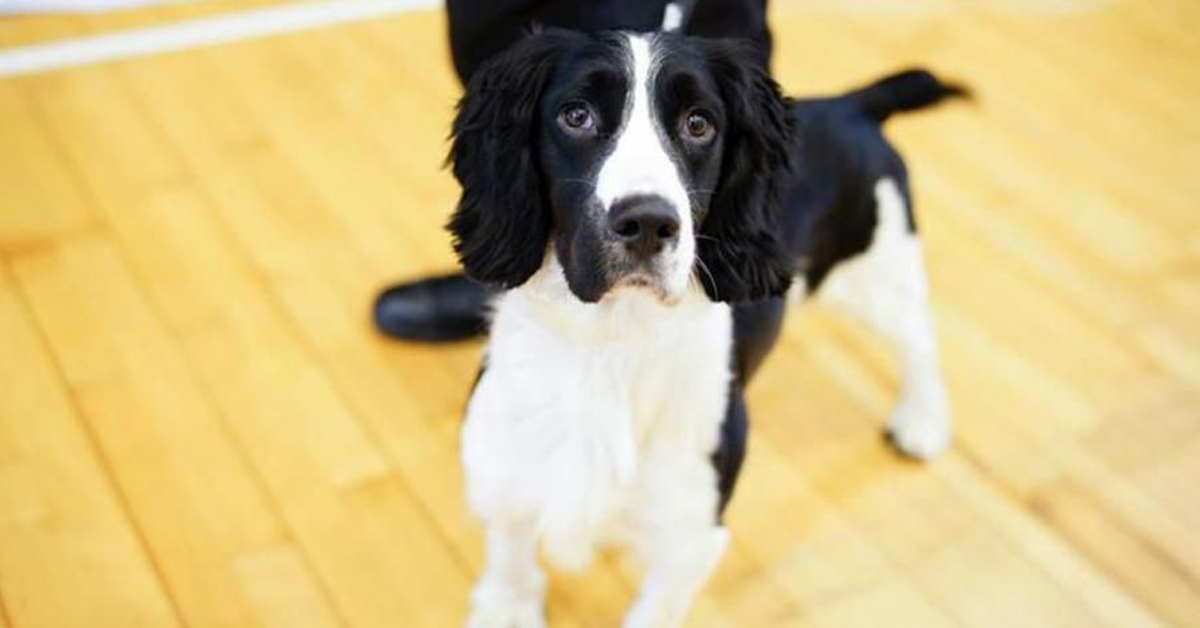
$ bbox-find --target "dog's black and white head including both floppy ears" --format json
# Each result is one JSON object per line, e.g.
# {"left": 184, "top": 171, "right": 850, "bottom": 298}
{"left": 449, "top": 30, "right": 793, "bottom": 303}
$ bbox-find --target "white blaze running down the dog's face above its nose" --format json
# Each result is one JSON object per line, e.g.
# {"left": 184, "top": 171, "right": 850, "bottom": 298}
{"left": 595, "top": 35, "right": 690, "bottom": 219}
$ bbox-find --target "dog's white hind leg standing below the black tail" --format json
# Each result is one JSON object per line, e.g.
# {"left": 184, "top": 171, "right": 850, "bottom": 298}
{"left": 817, "top": 177, "right": 950, "bottom": 459}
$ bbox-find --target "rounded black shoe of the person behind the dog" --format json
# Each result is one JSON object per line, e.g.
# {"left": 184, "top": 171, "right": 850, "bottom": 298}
{"left": 374, "top": 275, "right": 492, "bottom": 342}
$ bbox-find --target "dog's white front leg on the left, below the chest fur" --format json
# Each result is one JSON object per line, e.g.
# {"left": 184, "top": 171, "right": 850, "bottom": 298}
{"left": 467, "top": 521, "right": 546, "bottom": 628}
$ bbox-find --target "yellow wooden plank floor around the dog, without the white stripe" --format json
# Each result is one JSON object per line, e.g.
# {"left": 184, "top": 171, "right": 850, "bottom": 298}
{"left": 0, "top": 0, "right": 1200, "bottom": 628}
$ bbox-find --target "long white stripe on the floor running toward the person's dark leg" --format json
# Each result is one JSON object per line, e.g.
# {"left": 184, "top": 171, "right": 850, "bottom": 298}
{"left": 0, "top": 0, "right": 442, "bottom": 78}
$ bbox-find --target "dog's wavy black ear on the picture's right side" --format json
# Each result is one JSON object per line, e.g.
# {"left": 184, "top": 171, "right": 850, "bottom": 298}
{"left": 696, "top": 40, "right": 796, "bottom": 303}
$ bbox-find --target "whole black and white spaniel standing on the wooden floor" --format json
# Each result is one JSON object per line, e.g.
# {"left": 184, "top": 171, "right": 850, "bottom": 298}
{"left": 450, "top": 12, "right": 959, "bottom": 628}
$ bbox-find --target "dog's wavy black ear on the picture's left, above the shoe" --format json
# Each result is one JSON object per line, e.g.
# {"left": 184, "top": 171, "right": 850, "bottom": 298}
{"left": 448, "top": 30, "right": 568, "bottom": 288}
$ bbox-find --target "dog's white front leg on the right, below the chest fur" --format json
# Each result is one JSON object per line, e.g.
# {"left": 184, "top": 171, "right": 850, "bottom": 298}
{"left": 624, "top": 526, "right": 730, "bottom": 628}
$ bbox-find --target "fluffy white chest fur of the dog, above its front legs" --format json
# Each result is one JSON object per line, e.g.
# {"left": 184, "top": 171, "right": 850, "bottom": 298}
{"left": 462, "top": 263, "right": 732, "bottom": 568}
